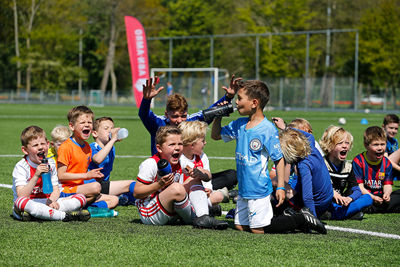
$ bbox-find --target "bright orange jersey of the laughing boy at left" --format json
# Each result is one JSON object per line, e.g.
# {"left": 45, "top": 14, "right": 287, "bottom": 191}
{"left": 57, "top": 138, "right": 92, "bottom": 187}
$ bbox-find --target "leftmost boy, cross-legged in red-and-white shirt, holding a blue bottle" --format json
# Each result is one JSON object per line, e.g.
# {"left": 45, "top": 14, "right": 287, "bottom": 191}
{"left": 12, "top": 126, "right": 90, "bottom": 222}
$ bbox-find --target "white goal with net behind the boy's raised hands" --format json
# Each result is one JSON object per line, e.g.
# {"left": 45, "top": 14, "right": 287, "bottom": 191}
{"left": 150, "top": 68, "right": 229, "bottom": 107}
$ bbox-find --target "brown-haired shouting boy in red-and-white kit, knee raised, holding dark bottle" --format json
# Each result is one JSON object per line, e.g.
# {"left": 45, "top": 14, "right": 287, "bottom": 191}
{"left": 134, "top": 126, "right": 228, "bottom": 229}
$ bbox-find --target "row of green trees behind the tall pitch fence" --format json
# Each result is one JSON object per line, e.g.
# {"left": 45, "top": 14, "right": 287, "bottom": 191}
{"left": 0, "top": 0, "right": 400, "bottom": 104}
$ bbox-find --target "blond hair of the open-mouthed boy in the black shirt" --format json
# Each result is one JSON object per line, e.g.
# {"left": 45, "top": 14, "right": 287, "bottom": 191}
{"left": 319, "top": 125, "right": 353, "bottom": 155}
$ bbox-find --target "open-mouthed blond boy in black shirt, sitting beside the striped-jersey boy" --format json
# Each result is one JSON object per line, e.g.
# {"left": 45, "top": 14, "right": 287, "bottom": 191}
{"left": 319, "top": 125, "right": 372, "bottom": 220}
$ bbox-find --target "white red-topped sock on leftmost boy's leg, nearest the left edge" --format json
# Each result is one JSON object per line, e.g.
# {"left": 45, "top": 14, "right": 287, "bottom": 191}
{"left": 14, "top": 197, "right": 65, "bottom": 221}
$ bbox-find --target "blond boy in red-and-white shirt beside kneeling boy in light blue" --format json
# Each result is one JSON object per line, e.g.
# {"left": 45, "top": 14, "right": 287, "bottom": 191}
{"left": 178, "top": 121, "right": 224, "bottom": 218}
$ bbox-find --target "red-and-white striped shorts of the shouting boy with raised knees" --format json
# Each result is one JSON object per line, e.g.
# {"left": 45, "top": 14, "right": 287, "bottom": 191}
{"left": 136, "top": 194, "right": 175, "bottom": 225}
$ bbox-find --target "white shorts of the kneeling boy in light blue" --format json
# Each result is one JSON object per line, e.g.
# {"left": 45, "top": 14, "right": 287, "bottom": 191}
{"left": 235, "top": 195, "right": 274, "bottom": 228}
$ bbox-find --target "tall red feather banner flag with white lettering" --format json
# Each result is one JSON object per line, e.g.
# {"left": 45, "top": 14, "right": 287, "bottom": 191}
{"left": 125, "top": 16, "right": 149, "bottom": 107}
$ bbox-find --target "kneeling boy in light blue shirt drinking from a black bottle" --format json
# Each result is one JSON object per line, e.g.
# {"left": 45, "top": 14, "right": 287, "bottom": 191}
{"left": 211, "top": 81, "right": 326, "bottom": 234}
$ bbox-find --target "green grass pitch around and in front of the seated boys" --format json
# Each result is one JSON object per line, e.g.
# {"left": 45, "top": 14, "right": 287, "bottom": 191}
{"left": 0, "top": 104, "right": 400, "bottom": 266}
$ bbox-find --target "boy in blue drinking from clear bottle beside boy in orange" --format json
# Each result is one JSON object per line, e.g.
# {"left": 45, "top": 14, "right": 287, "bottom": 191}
{"left": 85, "top": 117, "right": 135, "bottom": 204}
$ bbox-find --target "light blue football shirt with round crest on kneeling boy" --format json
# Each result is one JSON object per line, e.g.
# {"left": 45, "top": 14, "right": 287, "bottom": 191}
{"left": 221, "top": 118, "right": 283, "bottom": 199}
